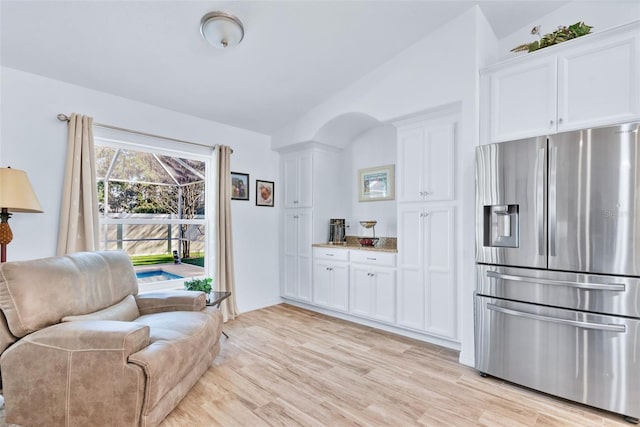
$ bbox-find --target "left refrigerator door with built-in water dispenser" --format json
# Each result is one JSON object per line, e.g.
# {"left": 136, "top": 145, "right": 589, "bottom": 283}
{"left": 476, "top": 137, "right": 547, "bottom": 268}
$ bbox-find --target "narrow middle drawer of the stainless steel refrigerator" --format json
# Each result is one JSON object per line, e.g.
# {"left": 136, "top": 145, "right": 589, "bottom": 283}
{"left": 476, "top": 265, "right": 640, "bottom": 318}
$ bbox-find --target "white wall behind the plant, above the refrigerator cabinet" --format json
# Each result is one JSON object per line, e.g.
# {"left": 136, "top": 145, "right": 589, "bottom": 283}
{"left": 498, "top": 0, "right": 640, "bottom": 58}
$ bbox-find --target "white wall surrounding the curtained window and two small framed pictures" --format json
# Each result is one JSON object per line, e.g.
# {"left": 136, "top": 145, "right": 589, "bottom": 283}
{"left": 0, "top": 67, "right": 280, "bottom": 311}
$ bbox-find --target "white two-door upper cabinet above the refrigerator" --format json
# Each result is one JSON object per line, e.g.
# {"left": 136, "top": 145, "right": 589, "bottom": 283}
{"left": 481, "top": 22, "right": 640, "bottom": 143}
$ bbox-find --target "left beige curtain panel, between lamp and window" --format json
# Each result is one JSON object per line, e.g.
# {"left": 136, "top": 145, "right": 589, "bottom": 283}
{"left": 57, "top": 113, "right": 98, "bottom": 255}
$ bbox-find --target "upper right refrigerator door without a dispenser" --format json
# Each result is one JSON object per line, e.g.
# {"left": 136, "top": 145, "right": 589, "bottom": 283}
{"left": 549, "top": 123, "right": 640, "bottom": 276}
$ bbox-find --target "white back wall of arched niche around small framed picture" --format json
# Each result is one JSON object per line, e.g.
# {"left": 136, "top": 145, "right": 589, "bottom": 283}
{"left": 342, "top": 125, "right": 398, "bottom": 237}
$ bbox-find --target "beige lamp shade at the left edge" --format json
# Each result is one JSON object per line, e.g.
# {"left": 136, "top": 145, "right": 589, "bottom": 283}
{"left": 0, "top": 168, "right": 42, "bottom": 213}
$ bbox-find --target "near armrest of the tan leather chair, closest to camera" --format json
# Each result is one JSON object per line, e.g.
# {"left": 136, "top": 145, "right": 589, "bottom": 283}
{"left": 0, "top": 320, "right": 149, "bottom": 426}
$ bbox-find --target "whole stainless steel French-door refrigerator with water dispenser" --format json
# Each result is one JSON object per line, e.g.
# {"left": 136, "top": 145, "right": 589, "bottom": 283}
{"left": 475, "top": 123, "right": 640, "bottom": 422}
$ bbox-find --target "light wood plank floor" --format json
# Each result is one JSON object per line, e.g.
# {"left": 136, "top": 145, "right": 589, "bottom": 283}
{"left": 162, "top": 304, "right": 630, "bottom": 427}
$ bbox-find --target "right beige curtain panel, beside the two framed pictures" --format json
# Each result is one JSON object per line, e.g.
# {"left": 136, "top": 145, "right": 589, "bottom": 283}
{"left": 215, "top": 145, "right": 238, "bottom": 322}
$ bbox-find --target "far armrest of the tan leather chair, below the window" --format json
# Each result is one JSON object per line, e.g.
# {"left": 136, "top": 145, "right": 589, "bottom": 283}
{"left": 136, "top": 291, "right": 207, "bottom": 315}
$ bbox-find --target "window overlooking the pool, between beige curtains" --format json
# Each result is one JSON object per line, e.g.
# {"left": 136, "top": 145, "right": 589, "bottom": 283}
{"left": 95, "top": 133, "right": 212, "bottom": 291}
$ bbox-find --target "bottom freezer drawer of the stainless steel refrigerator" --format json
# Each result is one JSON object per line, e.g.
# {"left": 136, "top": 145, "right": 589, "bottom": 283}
{"left": 475, "top": 296, "right": 640, "bottom": 418}
